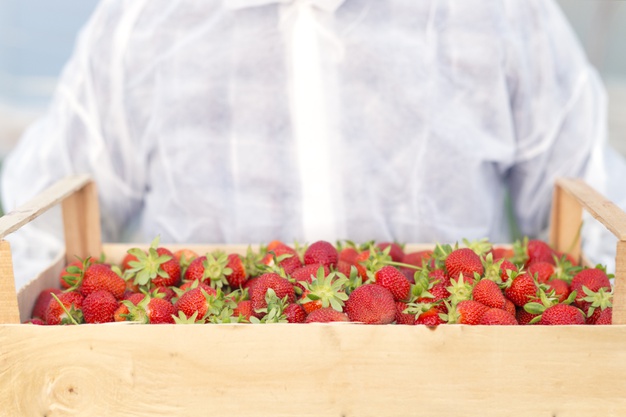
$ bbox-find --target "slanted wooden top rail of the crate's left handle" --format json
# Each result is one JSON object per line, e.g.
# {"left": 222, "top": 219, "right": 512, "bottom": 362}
{"left": 0, "top": 175, "right": 91, "bottom": 238}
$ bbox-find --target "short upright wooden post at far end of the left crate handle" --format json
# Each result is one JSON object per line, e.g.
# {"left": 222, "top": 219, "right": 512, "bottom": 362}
{"left": 62, "top": 182, "right": 102, "bottom": 263}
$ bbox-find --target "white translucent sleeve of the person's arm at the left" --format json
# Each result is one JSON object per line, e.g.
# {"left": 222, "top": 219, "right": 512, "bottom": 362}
{"left": 2, "top": 2, "right": 145, "bottom": 288}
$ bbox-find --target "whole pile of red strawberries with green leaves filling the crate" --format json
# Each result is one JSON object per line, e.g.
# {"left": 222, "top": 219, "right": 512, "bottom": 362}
{"left": 28, "top": 238, "right": 612, "bottom": 326}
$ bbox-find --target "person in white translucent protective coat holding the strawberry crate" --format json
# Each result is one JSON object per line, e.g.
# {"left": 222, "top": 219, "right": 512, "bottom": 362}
{"left": 2, "top": 0, "right": 626, "bottom": 286}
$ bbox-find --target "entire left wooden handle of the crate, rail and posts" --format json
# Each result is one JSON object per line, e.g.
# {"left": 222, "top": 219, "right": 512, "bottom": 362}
{"left": 0, "top": 175, "right": 102, "bottom": 323}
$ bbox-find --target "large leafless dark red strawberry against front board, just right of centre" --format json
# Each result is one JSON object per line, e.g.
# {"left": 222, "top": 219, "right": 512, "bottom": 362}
{"left": 344, "top": 284, "right": 396, "bottom": 324}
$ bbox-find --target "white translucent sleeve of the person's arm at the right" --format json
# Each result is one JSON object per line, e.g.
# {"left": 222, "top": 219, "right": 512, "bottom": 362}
{"left": 506, "top": 0, "right": 626, "bottom": 269}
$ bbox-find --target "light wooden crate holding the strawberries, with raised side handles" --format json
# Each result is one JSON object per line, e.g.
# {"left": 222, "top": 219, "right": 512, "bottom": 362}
{"left": 0, "top": 176, "right": 626, "bottom": 417}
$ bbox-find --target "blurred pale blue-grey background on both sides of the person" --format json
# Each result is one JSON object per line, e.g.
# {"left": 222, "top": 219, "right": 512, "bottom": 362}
{"left": 0, "top": 0, "right": 626, "bottom": 174}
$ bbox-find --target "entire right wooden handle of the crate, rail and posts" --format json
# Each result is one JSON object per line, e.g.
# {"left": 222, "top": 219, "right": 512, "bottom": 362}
{"left": 550, "top": 178, "right": 626, "bottom": 324}
